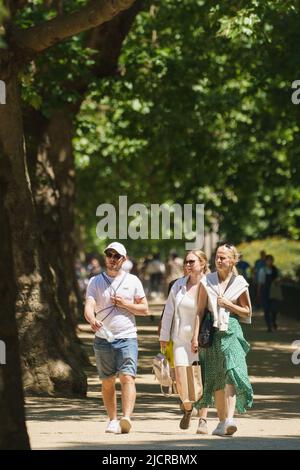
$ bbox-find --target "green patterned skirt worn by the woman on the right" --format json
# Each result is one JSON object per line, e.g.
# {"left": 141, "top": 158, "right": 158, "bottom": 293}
{"left": 195, "top": 314, "right": 253, "bottom": 413}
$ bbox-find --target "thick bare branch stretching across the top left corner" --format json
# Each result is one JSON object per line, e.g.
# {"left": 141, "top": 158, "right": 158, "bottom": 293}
{"left": 10, "top": 0, "right": 135, "bottom": 54}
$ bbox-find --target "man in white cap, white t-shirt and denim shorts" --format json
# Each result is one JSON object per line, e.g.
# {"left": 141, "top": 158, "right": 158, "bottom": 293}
{"left": 84, "top": 242, "right": 148, "bottom": 434}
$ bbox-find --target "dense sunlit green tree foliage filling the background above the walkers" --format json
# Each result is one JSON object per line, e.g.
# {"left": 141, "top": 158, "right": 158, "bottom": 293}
{"left": 2, "top": 0, "right": 300, "bottom": 255}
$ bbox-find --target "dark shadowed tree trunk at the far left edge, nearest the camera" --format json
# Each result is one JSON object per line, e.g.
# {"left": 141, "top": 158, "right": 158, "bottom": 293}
{"left": 0, "top": 127, "right": 29, "bottom": 450}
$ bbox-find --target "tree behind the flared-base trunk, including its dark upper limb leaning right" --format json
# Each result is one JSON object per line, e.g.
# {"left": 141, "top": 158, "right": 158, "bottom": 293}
{"left": 24, "top": 1, "right": 141, "bottom": 328}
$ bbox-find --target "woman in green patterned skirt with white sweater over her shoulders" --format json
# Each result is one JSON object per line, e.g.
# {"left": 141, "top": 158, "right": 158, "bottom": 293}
{"left": 192, "top": 244, "right": 253, "bottom": 436}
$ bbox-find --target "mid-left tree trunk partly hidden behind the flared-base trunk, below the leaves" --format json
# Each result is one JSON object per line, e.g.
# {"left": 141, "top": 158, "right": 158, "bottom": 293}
{"left": 25, "top": 107, "right": 83, "bottom": 332}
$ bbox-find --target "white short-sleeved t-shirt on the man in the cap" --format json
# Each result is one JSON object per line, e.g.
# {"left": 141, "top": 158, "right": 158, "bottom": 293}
{"left": 86, "top": 271, "right": 145, "bottom": 339}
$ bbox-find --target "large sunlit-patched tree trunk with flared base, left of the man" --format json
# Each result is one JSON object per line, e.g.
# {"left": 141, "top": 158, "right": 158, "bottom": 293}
{"left": 0, "top": 66, "right": 87, "bottom": 396}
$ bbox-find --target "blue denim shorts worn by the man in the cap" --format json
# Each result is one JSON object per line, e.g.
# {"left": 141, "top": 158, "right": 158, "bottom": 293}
{"left": 94, "top": 336, "right": 138, "bottom": 379}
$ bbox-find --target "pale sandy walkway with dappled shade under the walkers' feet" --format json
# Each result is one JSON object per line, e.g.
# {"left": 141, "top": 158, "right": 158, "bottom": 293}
{"left": 26, "top": 305, "right": 300, "bottom": 450}
